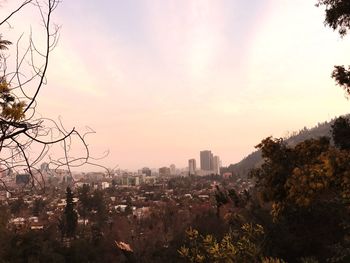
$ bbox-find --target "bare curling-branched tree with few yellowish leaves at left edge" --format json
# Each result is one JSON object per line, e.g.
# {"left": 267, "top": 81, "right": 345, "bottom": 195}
{"left": 0, "top": 0, "right": 93, "bottom": 194}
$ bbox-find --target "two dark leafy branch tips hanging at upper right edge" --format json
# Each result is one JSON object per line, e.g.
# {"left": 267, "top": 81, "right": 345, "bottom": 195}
{"left": 316, "top": 0, "right": 350, "bottom": 95}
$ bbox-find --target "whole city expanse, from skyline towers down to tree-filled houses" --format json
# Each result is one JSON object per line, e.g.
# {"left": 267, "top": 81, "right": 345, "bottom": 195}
{"left": 0, "top": 145, "right": 253, "bottom": 262}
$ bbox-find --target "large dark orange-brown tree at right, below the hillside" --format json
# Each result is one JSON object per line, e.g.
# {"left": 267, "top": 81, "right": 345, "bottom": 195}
{"left": 251, "top": 137, "right": 350, "bottom": 262}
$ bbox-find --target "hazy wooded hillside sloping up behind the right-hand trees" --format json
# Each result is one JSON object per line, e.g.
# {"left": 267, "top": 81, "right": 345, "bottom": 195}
{"left": 223, "top": 115, "right": 350, "bottom": 177}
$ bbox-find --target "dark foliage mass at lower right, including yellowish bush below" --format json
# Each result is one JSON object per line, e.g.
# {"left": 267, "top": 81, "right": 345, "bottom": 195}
{"left": 180, "top": 118, "right": 350, "bottom": 263}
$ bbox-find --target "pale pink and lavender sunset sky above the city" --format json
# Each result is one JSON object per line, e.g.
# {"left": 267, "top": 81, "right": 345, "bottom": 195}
{"left": 2, "top": 0, "right": 350, "bottom": 170}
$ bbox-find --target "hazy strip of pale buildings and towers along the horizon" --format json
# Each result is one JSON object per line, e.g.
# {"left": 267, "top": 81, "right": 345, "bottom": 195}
{"left": 0, "top": 150, "right": 224, "bottom": 197}
